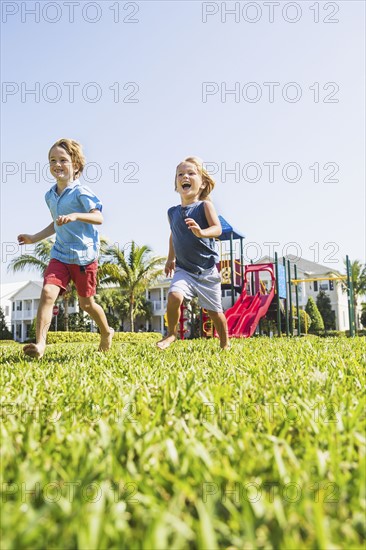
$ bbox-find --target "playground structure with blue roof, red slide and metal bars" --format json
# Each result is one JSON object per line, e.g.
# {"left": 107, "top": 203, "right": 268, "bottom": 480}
{"left": 179, "top": 216, "right": 355, "bottom": 338}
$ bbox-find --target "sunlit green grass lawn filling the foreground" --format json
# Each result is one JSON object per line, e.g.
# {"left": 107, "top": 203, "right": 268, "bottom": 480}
{"left": 0, "top": 337, "right": 366, "bottom": 550}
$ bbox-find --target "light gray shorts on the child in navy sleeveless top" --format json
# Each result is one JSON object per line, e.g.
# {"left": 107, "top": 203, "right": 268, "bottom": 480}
{"left": 169, "top": 266, "right": 222, "bottom": 313}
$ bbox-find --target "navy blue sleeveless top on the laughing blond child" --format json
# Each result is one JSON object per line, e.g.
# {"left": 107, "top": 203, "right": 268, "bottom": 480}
{"left": 168, "top": 201, "right": 219, "bottom": 273}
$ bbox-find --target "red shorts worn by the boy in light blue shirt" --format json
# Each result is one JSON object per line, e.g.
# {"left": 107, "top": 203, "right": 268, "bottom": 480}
{"left": 43, "top": 258, "right": 98, "bottom": 298}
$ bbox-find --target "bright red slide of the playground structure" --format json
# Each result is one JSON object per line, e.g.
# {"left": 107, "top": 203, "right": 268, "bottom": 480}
{"left": 225, "top": 264, "right": 276, "bottom": 338}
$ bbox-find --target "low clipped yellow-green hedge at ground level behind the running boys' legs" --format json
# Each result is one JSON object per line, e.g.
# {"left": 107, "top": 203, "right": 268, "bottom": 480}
{"left": 47, "top": 332, "right": 162, "bottom": 344}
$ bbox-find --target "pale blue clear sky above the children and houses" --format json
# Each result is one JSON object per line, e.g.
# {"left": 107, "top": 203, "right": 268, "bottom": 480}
{"left": 1, "top": 0, "right": 366, "bottom": 282}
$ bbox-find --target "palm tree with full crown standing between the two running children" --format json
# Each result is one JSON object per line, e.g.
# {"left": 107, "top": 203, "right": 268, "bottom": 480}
{"left": 99, "top": 241, "right": 165, "bottom": 332}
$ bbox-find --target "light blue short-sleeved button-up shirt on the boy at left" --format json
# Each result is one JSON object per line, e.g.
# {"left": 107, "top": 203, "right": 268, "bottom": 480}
{"left": 45, "top": 180, "right": 103, "bottom": 265}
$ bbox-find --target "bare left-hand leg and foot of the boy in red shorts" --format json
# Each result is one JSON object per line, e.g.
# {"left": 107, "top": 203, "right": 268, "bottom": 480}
{"left": 23, "top": 284, "right": 60, "bottom": 359}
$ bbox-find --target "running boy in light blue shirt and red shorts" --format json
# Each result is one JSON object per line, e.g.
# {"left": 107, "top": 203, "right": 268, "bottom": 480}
{"left": 18, "top": 139, "right": 114, "bottom": 359}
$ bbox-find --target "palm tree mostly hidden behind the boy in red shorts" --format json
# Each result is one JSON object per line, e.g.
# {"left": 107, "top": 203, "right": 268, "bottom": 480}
{"left": 8, "top": 238, "right": 75, "bottom": 331}
